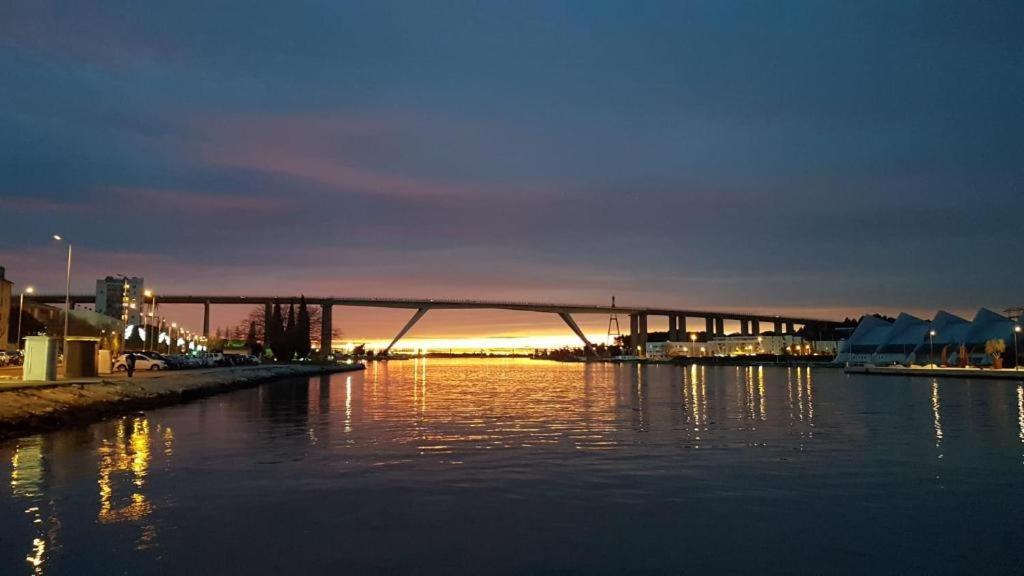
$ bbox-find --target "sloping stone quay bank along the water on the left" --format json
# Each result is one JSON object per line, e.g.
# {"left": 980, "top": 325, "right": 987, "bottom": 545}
{"left": 0, "top": 364, "right": 365, "bottom": 440}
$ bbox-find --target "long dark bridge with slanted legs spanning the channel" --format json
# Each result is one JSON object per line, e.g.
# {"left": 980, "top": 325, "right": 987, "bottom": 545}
{"left": 26, "top": 294, "right": 839, "bottom": 354}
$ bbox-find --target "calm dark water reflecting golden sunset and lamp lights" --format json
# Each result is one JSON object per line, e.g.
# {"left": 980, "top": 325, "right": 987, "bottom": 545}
{"left": 0, "top": 360, "right": 1024, "bottom": 575}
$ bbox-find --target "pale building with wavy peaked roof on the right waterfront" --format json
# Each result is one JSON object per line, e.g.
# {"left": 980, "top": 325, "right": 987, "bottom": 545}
{"left": 836, "top": 308, "right": 1019, "bottom": 366}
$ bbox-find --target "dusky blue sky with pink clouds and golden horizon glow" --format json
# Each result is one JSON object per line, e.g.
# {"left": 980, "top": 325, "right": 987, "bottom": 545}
{"left": 0, "top": 0, "right": 1024, "bottom": 340}
